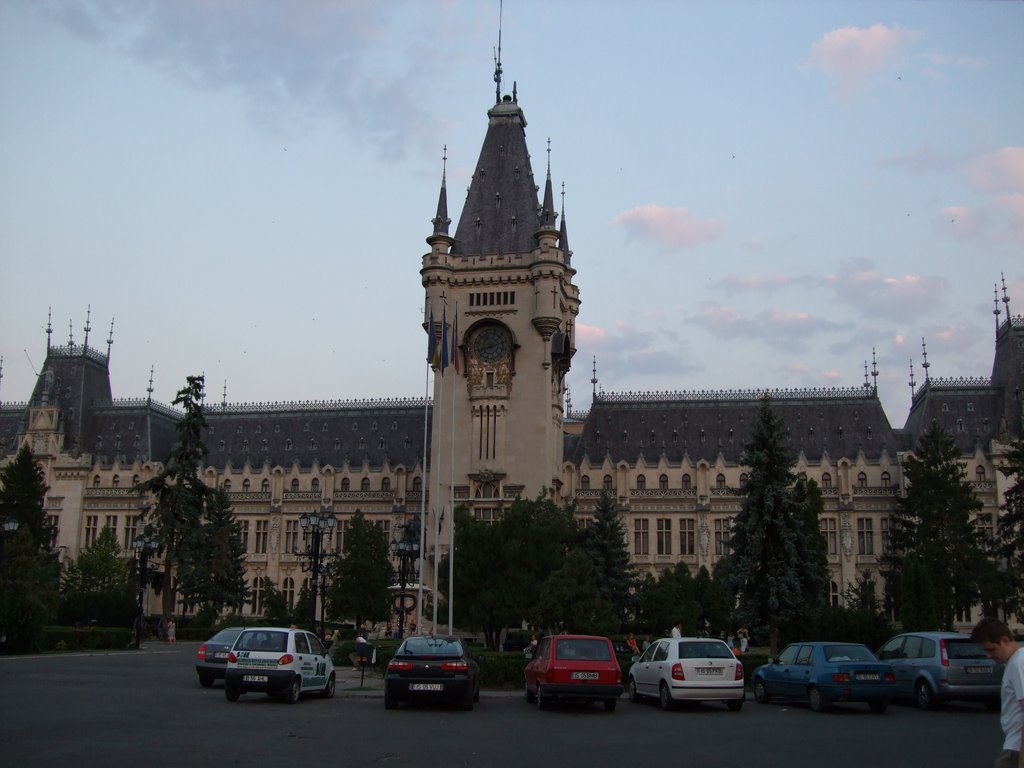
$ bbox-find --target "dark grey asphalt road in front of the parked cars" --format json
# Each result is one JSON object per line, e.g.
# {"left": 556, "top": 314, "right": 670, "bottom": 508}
{"left": 0, "top": 643, "right": 1001, "bottom": 768}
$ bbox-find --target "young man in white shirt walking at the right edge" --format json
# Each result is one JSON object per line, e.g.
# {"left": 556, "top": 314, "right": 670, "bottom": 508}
{"left": 971, "top": 617, "right": 1024, "bottom": 768}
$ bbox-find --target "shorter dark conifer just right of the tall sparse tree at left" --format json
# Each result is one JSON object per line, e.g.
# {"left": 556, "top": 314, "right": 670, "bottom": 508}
{"left": 180, "top": 488, "right": 249, "bottom": 613}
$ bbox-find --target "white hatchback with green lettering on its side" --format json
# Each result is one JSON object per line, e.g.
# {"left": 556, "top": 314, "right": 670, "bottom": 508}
{"left": 224, "top": 627, "right": 335, "bottom": 703}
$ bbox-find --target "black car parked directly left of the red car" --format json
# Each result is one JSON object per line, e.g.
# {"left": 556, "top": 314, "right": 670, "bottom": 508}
{"left": 384, "top": 636, "right": 482, "bottom": 710}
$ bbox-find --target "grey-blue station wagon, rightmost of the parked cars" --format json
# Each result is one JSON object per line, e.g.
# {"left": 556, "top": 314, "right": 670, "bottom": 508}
{"left": 879, "top": 632, "right": 1002, "bottom": 710}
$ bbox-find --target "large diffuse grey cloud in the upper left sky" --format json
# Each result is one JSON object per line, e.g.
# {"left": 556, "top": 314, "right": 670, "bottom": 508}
{"left": 51, "top": 0, "right": 446, "bottom": 160}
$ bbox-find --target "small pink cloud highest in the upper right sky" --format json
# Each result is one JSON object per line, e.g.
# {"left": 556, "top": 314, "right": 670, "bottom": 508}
{"left": 806, "top": 24, "right": 919, "bottom": 97}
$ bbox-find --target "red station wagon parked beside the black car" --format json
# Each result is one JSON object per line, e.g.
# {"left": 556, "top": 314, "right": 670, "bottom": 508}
{"left": 524, "top": 635, "right": 623, "bottom": 712}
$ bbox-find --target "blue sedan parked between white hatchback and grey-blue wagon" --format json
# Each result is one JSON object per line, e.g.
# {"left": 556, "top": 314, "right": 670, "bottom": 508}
{"left": 754, "top": 642, "right": 896, "bottom": 713}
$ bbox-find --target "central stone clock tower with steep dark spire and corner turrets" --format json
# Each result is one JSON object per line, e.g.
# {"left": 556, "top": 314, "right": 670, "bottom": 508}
{"left": 420, "top": 81, "right": 580, "bottom": 532}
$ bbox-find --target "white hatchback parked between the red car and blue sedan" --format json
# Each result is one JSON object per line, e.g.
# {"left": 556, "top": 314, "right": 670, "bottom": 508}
{"left": 627, "top": 637, "right": 745, "bottom": 712}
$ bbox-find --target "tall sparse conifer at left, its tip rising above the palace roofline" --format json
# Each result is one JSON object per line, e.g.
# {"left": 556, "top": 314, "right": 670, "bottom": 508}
{"left": 138, "top": 376, "right": 213, "bottom": 620}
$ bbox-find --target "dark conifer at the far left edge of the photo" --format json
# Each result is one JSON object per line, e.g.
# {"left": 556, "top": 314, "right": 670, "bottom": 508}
{"left": 0, "top": 445, "right": 59, "bottom": 652}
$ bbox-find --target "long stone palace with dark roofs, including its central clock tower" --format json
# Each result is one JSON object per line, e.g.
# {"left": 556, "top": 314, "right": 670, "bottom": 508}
{"left": 0, "top": 73, "right": 1024, "bottom": 630}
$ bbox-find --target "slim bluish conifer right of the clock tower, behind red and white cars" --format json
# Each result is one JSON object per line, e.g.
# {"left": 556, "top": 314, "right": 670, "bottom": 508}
{"left": 583, "top": 490, "right": 637, "bottom": 632}
